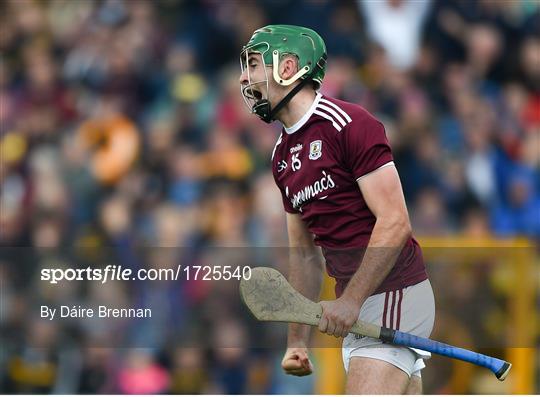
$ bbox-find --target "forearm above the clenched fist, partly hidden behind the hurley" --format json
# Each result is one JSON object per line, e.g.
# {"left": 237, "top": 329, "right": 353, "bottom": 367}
{"left": 287, "top": 247, "right": 324, "bottom": 347}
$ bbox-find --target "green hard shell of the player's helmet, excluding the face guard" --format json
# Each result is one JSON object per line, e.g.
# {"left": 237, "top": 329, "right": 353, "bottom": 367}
{"left": 241, "top": 25, "right": 326, "bottom": 88}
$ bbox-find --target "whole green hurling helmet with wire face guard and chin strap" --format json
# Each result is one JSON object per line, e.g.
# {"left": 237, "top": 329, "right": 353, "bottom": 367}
{"left": 240, "top": 25, "right": 326, "bottom": 123}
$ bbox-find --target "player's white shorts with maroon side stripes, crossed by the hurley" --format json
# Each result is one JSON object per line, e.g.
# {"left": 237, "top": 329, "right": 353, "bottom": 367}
{"left": 341, "top": 280, "right": 435, "bottom": 377}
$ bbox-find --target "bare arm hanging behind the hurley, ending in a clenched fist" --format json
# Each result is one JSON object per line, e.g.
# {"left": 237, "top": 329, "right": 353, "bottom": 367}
{"left": 281, "top": 213, "right": 324, "bottom": 376}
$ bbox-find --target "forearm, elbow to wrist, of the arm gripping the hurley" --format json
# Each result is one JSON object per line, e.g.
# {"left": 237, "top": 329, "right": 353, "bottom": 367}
{"left": 343, "top": 216, "right": 411, "bottom": 305}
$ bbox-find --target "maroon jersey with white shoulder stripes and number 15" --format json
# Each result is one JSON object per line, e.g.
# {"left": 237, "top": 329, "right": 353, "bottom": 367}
{"left": 272, "top": 94, "right": 427, "bottom": 297}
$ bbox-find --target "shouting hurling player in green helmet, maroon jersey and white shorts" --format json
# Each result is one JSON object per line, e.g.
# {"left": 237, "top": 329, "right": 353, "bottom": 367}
{"left": 240, "top": 25, "right": 435, "bottom": 394}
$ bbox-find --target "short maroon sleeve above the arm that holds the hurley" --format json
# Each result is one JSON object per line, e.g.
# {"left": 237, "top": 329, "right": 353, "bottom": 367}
{"left": 342, "top": 115, "right": 393, "bottom": 179}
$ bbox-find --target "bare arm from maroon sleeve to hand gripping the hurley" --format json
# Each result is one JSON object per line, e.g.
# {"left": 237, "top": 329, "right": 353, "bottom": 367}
{"left": 319, "top": 165, "right": 411, "bottom": 336}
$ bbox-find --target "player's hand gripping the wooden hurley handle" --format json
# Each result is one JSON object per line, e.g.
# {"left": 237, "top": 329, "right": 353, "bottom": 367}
{"left": 319, "top": 296, "right": 362, "bottom": 338}
